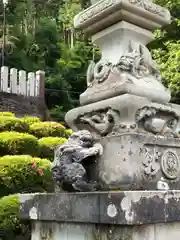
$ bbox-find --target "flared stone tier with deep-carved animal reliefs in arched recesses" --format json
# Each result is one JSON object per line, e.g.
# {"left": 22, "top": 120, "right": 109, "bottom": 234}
{"left": 65, "top": 94, "right": 180, "bottom": 138}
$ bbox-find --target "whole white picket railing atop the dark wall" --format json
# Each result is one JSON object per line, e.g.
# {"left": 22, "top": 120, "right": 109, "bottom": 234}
{"left": 0, "top": 66, "right": 45, "bottom": 97}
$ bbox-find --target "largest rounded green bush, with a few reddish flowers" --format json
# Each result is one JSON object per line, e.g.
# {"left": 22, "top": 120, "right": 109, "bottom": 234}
{"left": 0, "top": 155, "right": 53, "bottom": 196}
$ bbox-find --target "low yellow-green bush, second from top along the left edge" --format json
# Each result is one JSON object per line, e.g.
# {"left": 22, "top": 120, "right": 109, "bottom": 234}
{"left": 0, "top": 115, "right": 29, "bottom": 132}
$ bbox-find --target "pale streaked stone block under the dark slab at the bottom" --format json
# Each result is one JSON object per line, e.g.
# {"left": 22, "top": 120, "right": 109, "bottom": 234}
{"left": 29, "top": 222, "right": 180, "bottom": 240}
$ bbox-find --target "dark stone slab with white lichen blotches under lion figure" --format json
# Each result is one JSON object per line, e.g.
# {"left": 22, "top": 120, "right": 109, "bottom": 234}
{"left": 20, "top": 191, "right": 180, "bottom": 225}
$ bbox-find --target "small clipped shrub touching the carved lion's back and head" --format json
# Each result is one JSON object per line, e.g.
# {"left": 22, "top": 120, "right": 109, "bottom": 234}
{"left": 39, "top": 137, "right": 67, "bottom": 160}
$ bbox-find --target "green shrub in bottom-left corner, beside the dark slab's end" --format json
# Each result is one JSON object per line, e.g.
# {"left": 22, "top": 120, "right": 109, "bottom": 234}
{"left": 0, "top": 195, "right": 30, "bottom": 240}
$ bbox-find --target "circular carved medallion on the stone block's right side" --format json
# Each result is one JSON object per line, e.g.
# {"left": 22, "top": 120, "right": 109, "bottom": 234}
{"left": 161, "top": 150, "right": 180, "bottom": 179}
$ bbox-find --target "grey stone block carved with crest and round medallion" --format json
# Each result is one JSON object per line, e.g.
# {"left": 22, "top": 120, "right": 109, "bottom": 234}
{"left": 92, "top": 133, "right": 180, "bottom": 190}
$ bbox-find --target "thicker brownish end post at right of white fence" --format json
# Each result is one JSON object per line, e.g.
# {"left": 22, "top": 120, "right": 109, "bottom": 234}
{"left": 36, "top": 70, "right": 45, "bottom": 99}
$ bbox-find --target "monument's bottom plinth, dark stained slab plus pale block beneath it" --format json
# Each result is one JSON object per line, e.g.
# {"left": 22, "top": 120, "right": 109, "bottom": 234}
{"left": 20, "top": 191, "right": 180, "bottom": 240}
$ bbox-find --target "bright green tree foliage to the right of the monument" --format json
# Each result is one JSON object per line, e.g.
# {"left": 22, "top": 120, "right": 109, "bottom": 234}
{"left": 150, "top": 0, "right": 180, "bottom": 103}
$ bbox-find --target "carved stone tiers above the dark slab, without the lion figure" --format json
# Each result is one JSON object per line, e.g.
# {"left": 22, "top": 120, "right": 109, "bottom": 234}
{"left": 63, "top": 0, "right": 180, "bottom": 190}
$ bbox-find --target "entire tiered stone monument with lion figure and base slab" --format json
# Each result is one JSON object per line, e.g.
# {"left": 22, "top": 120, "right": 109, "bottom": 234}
{"left": 20, "top": 0, "right": 180, "bottom": 240}
